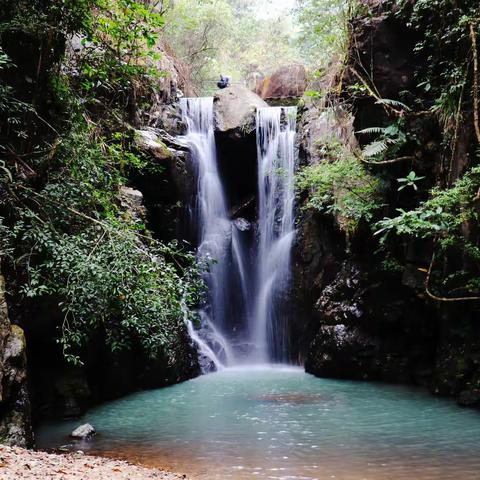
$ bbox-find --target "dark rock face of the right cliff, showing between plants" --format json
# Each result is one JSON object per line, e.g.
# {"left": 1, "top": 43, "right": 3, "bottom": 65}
{"left": 294, "top": 0, "right": 480, "bottom": 407}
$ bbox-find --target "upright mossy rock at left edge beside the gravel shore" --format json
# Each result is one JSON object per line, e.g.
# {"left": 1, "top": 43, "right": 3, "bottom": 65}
{"left": 0, "top": 275, "right": 32, "bottom": 447}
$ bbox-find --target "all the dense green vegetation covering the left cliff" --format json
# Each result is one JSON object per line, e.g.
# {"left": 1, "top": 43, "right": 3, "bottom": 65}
{"left": 0, "top": 0, "right": 201, "bottom": 362}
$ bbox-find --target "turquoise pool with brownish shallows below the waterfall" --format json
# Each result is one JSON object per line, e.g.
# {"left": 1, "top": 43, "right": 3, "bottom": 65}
{"left": 37, "top": 368, "right": 480, "bottom": 480}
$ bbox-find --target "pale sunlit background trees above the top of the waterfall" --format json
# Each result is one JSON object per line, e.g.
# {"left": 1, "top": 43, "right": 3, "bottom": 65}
{"left": 162, "top": 0, "right": 350, "bottom": 93}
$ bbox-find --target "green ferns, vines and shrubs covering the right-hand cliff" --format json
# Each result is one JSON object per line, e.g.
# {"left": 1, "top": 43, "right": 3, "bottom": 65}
{"left": 299, "top": 0, "right": 480, "bottom": 300}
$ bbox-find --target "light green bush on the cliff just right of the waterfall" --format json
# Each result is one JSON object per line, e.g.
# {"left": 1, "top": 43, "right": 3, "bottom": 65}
{"left": 297, "top": 140, "right": 382, "bottom": 233}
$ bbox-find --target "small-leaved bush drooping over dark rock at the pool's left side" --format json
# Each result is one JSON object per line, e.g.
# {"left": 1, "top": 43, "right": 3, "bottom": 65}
{"left": 16, "top": 217, "right": 197, "bottom": 362}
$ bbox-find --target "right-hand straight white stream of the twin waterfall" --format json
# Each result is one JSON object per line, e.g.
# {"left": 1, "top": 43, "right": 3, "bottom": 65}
{"left": 252, "top": 107, "right": 297, "bottom": 361}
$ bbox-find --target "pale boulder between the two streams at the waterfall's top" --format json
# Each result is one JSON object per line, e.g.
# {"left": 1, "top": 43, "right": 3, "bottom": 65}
{"left": 214, "top": 85, "right": 268, "bottom": 136}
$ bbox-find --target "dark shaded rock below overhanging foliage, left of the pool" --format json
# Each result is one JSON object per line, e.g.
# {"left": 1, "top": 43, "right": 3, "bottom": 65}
{"left": 27, "top": 312, "right": 200, "bottom": 422}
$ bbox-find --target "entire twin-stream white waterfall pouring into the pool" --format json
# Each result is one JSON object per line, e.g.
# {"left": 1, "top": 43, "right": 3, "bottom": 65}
{"left": 180, "top": 98, "right": 296, "bottom": 369}
